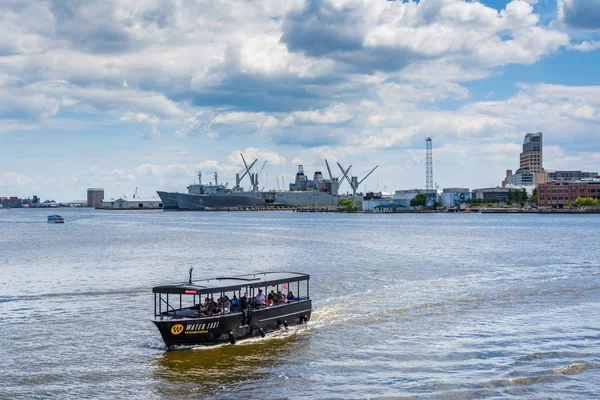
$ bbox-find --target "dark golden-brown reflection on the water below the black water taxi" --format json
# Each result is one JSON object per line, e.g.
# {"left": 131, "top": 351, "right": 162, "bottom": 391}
{"left": 155, "top": 331, "right": 309, "bottom": 396}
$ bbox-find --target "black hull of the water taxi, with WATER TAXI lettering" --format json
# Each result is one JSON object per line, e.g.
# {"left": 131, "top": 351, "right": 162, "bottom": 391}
{"left": 152, "top": 299, "right": 312, "bottom": 347}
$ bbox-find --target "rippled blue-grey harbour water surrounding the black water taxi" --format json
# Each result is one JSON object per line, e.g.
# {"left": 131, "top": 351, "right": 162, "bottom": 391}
{"left": 0, "top": 209, "right": 600, "bottom": 399}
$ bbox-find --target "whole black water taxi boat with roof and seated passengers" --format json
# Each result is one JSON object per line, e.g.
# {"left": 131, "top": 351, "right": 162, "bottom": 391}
{"left": 152, "top": 269, "right": 312, "bottom": 347}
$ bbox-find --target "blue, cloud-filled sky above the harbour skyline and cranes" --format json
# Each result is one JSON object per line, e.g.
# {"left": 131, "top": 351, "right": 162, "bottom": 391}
{"left": 0, "top": 0, "right": 600, "bottom": 201}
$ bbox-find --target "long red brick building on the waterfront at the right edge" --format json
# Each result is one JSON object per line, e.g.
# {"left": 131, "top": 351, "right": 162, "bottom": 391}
{"left": 538, "top": 179, "right": 600, "bottom": 208}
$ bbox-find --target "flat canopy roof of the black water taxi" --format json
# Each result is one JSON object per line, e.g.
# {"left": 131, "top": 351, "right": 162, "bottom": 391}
{"left": 152, "top": 272, "right": 310, "bottom": 294}
